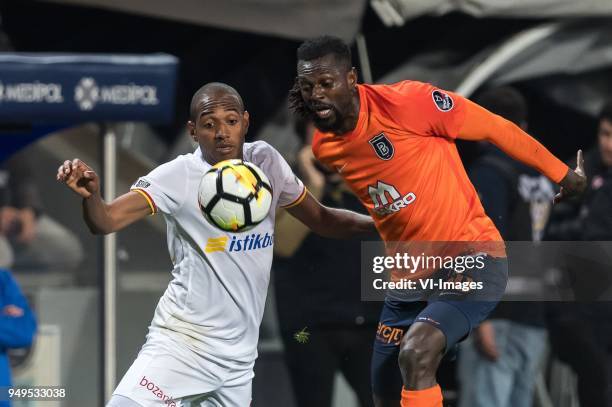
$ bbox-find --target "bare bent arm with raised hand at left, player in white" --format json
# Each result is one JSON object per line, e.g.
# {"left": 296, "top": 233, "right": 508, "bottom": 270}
{"left": 56, "top": 158, "right": 151, "bottom": 234}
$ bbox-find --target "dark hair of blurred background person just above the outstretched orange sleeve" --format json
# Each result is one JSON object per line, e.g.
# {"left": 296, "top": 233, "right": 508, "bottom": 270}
{"left": 476, "top": 86, "right": 527, "bottom": 126}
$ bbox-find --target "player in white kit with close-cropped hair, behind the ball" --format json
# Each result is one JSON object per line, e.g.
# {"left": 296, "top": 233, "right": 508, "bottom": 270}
{"left": 57, "top": 83, "right": 375, "bottom": 407}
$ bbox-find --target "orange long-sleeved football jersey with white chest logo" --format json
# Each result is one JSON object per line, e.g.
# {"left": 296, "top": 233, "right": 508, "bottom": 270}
{"left": 312, "top": 81, "right": 567, "bottom": 255}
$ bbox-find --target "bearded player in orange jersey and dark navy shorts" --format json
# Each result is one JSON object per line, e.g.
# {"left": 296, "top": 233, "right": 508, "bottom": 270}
{"left": 289, "top": 36, "right": 586, "bottom": 407}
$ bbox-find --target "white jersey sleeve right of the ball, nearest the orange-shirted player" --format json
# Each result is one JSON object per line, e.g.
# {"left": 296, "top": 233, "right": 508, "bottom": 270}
{"left": 247, "top": 141, "right": 307, "bottom": 208}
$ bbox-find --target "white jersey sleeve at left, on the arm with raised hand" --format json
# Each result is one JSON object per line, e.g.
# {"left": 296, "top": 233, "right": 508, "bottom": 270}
{"left": 130, "top": 158, "right": 187, "bottom": 214}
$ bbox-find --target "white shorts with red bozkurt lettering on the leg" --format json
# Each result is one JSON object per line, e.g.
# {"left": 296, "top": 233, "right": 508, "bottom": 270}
{"left": 107, "top": 334, "right": 254, "bottom": 407}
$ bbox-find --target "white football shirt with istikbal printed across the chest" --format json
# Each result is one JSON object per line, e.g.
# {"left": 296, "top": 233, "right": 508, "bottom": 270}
{"left": 131, "top": 141, "right": 306, "bottom": 367}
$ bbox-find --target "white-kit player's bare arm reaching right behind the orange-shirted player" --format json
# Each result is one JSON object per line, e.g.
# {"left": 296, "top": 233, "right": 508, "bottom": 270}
{"left": 287, "top": 192, "right": 376, "bottom": 239}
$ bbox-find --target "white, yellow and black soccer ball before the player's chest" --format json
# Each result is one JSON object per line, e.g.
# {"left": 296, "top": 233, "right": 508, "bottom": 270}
{"left": 198, "top": 159, "right": 272, "bottom": 232}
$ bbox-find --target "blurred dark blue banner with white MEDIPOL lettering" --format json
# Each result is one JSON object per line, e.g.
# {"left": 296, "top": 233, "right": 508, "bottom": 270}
{"left": 0, "top": 53, "right": 178, "bottom": 124}
